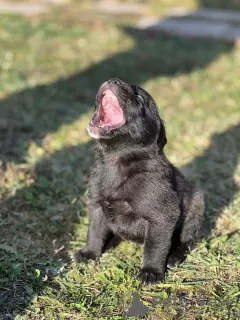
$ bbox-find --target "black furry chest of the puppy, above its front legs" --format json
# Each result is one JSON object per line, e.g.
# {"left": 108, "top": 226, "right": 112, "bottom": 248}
{"left": 96, "top": 158, "right": 146, "bottom": 241}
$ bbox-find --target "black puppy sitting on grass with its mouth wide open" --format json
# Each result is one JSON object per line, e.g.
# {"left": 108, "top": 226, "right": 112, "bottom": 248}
{"left": 74, "top": 79, "right": 204, "bottom": 283}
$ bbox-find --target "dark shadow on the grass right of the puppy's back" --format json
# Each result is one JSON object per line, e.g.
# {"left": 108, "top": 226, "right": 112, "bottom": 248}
{"left": 181, "top": 124, "right": 240, "bottom": 237}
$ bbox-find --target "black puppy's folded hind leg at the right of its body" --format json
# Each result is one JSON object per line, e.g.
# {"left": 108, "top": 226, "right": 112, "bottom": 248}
{"left": 168, "top": 191, "right": 204, "bottom": 267}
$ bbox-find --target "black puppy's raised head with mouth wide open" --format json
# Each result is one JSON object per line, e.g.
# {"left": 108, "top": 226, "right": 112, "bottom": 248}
{"left": 87, "top": 79, "right": 167, "bottom": 148}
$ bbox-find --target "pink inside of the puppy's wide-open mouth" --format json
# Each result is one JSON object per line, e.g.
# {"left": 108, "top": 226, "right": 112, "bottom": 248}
{"left": 92, "top": 90, "right": 124, "bottom": 127}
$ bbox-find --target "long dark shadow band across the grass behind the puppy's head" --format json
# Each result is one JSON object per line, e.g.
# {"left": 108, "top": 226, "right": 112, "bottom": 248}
{"left": 0, "top": 27, "right": 234, "bottom": 163}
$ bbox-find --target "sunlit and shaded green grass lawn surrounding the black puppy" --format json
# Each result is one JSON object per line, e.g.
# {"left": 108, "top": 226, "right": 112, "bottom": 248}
{"left": 0, "top": 1, "right": 240, "bottom": 320}
